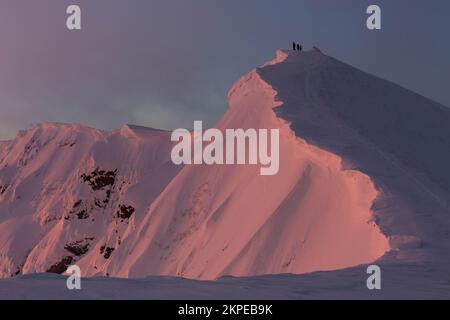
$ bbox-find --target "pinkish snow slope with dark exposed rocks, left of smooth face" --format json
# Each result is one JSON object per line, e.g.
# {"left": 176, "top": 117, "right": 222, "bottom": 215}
{"left": 0, "top": 124, "right": 179, "bottom": 277}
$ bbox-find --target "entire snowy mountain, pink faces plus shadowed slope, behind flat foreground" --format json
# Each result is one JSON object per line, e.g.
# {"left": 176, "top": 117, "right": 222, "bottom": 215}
{"left": 0, "top": 50, "right": 450, "bottom": 288}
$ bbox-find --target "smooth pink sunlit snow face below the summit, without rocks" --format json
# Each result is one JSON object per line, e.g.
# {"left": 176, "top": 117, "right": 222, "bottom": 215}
{"left": 108, "top": 70, "right": 388, "bottom": 279}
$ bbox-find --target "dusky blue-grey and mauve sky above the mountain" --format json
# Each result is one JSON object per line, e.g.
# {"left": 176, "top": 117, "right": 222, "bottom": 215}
{"left": 0, "top": 0, "right": 450, "bottom": 139}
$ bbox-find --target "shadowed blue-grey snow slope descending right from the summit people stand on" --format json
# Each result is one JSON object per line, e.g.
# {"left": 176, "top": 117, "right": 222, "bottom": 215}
{"left": 258, "top": 50, "right": 450, "bottom": 266}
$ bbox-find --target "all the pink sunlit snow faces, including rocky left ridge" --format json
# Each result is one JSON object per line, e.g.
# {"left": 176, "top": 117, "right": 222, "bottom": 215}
{"left": 0, "top": 48, "right": 390, "bottom": 279}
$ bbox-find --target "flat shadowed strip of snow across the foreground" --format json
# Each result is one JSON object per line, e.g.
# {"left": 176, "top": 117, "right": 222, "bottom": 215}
{"left": 0, "top": 264, "right": 450, "bottom": 300}
